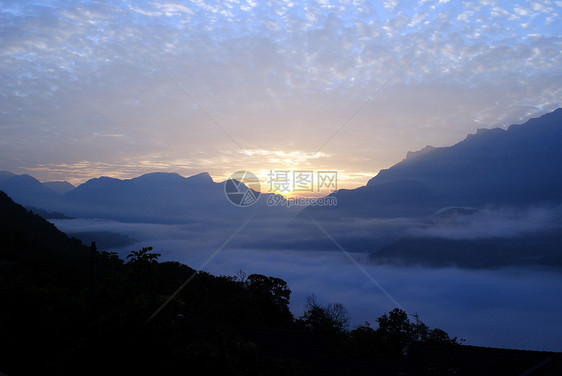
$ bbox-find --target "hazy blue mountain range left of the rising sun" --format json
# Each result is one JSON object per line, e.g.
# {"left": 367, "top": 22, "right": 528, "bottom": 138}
{"left": 0, "top": 172, "right": 299, "bottom": 226}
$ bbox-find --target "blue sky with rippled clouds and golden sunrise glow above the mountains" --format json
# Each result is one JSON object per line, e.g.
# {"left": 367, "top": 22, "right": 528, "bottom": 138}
{"left": 0, "top": 0, "right": 562, "bottom": 192}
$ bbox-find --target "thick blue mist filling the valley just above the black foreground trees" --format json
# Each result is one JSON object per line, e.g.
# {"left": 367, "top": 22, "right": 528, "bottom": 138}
{"left": 55, "top": 220, "right": 562, "bottom": 351}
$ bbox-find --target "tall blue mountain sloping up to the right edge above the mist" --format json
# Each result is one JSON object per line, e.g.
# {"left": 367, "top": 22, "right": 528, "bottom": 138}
{"left": 306, "top": 109, "right": 562, "bottom": 223}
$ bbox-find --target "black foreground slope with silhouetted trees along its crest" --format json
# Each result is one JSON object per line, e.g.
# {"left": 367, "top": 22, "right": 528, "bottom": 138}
{"left": 0, "top": 191, "right": 562, "bottom": 375}
